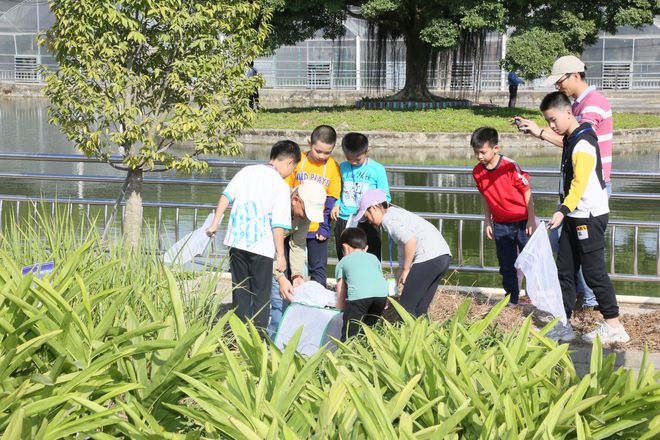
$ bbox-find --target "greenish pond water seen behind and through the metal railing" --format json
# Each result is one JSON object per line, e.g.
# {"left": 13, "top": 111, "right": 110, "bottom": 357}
{"left": 0, "top": 98, "right": 660, "bottom": 296}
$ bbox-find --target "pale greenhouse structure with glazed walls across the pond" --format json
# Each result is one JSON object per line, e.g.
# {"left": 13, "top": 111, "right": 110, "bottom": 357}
{"left": 0, "top": 0, "right": 660, "bottom": 90}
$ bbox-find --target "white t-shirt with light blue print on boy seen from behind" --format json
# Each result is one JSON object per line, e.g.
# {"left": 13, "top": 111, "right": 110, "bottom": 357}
{"left": 222, "top": 165, "right": 291, "bottom": 258}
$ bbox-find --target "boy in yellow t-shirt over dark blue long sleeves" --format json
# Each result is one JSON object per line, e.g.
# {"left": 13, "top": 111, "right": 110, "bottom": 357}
{"left": 287, "top": 125, "right": 341, "bottom": 286}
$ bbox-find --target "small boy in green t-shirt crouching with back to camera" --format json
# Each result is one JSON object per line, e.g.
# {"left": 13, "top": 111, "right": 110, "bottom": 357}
{"left": 335, "top": 228, "right": 387, "bottom": 340}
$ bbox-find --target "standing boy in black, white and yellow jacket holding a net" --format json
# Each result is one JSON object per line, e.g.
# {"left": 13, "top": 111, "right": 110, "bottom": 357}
{"left": 541, "top": 92, "right": 630, "bottom": 343}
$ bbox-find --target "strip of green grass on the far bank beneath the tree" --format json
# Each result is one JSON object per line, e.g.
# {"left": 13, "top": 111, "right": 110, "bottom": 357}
{"left": 254, "top": 106, "right": 660, "bottom": 133}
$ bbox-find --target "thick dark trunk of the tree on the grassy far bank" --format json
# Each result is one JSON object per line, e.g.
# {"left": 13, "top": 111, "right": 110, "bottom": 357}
{"left": 386, "top": 32, "right": 441, "bottom": 101}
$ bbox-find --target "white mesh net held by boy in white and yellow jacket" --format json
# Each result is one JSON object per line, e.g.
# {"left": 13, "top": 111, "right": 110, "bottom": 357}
{"left": 515, "top": 222, "right": 568, "bottom": 325}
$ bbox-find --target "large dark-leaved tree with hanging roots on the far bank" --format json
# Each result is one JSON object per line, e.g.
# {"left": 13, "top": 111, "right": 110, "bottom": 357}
{"left": 266, "top": 0, "right": 660, "bottom": 100}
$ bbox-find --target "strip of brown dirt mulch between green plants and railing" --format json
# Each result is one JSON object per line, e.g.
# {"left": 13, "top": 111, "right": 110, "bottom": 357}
{"left": 422, "top": 291, "right": 660, "bottom": 352}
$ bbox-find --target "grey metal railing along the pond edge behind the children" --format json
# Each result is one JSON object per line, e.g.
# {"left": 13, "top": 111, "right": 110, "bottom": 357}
{"left": 0, "top": 152, "right": 660, "bottom": 282}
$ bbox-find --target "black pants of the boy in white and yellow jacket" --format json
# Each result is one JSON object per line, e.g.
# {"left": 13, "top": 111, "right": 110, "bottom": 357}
{"left": 557, "top": 214, "right": 619, "bottom": 319}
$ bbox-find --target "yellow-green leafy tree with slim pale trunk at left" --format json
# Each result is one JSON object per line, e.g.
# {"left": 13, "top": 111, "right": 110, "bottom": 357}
{"left": 41, "top": 0, "right": 269, "bottom": 246}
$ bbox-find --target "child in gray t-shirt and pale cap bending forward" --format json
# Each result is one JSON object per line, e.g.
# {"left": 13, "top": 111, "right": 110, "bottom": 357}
{"left": 356, "top": 189, "right": 451, "bottom": 316}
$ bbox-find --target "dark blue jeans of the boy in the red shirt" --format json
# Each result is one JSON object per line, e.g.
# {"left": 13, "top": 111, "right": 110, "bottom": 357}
{"left": 493, "top": 220, "right": 529, "bottom": 304}
